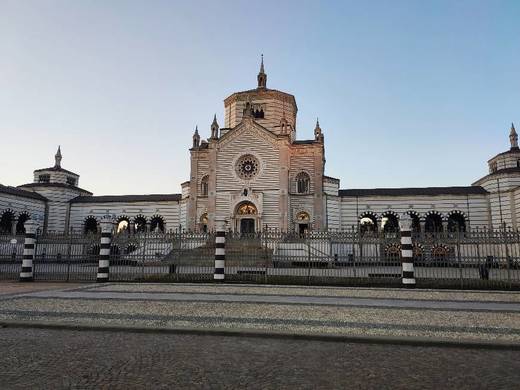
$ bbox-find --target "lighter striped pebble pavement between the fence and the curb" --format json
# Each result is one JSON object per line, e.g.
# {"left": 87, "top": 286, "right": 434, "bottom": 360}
{"left": 0, "top": 283, "right": 520, "bottom": 344}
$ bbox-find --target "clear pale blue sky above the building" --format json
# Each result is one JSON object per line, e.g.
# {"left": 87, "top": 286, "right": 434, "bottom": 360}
{"left": 0, "top": 0, "right": 520, "bottom": 195}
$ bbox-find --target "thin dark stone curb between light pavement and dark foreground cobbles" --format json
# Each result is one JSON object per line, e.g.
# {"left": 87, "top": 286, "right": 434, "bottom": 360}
{"left": 0, "top": 320, "right": 520, "bottom": 351}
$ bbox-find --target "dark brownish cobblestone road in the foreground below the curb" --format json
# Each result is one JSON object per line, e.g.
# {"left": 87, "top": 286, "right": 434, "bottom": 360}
{"left": 0, "top": 328, "right": 520, "bottom": 389}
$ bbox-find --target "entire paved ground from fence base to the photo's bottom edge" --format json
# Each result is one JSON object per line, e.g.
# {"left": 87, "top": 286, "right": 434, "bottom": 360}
{"left": 0, "top": 282, "right": 520, "bottom": 389}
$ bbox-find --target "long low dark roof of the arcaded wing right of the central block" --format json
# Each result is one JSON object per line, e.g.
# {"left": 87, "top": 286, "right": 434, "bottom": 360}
{"left": 339, "top": 186, "right": 488, "bottom": 197}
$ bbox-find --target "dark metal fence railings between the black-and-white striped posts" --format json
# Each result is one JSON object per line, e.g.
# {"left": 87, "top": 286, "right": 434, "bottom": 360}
{"left": 0, "top": 229, "right": 520, "bottom": 289}
